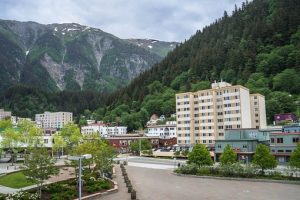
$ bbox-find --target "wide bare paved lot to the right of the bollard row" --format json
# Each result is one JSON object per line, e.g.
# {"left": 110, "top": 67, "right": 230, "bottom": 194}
{"left": 126, "top": 166, "right": 300, "bottom": 200}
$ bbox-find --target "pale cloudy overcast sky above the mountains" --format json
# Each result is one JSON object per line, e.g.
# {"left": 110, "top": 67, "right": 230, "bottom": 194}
{"left": 0, "top": 0, "right": 243, "bottom": 42}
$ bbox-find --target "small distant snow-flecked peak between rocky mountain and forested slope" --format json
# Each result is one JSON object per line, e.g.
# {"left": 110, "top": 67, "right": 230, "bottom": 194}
{"left": 127, "top": 39, "right": 179, "bottom": 57}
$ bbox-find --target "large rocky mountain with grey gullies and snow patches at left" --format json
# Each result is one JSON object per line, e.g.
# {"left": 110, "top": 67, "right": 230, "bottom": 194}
{"left": 0, "top": 20, "right": 172, "bottom": 91}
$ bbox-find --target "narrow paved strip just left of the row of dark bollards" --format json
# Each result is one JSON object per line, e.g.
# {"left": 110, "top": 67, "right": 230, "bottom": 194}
{"left": 99, "top": 165, "right": 130, "bottom": 200}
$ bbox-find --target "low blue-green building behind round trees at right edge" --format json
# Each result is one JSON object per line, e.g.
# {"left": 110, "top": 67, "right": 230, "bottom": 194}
{"left": 215, "top": 124, "right": 300, "bottom": 163}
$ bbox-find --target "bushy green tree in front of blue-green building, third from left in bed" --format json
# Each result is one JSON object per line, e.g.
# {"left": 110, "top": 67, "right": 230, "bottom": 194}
{"left": 252, "top": 144, "right": 277, "bottom": 174}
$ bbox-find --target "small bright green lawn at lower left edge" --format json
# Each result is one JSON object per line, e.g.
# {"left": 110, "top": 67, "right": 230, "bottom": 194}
{"left": 0, "top": 172, "right": 34, "bottom": 188}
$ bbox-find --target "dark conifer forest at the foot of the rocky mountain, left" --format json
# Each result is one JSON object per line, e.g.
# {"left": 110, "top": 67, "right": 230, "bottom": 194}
{"left": 0, "top": 85, "right": 107, "bottom": 122}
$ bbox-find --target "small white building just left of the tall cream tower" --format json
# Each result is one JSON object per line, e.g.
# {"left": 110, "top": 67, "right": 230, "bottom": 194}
{"left": 146, "top": 121, "right": 177, "bottom": 139}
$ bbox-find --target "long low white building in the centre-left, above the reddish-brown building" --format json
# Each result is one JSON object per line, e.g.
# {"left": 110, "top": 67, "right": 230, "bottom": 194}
{"left": 81, "top": 123, "right": 127, "bottom": 137}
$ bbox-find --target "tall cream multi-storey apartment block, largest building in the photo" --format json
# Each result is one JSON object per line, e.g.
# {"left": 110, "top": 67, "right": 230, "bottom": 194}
{"left": 176, "top": 81, "right": 266, "bottom": 147}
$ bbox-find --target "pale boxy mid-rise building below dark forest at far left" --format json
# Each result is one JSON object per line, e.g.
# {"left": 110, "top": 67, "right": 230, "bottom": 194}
{"left": 35, "top": 112, "right": 73, "bottom": 129}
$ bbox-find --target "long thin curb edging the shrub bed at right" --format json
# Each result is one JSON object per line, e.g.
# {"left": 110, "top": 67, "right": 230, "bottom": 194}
{"left": 172, "top": 172, "right": 300, "bottom": 185}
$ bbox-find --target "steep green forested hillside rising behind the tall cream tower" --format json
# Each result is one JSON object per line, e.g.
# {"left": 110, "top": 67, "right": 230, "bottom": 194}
{"left": 2, "top": 0, "right": 300, "bottom": 130}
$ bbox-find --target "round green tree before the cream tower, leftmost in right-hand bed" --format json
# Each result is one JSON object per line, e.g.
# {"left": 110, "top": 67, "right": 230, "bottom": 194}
{"left": 188, "top": 144, "right": 213, "bottom": 167}
